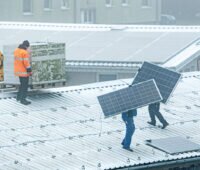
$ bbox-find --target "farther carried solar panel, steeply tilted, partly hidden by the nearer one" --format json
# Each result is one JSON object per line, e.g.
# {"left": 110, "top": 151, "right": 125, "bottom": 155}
{"left": 132, "top": 62, "right": 181, "bottom": 103}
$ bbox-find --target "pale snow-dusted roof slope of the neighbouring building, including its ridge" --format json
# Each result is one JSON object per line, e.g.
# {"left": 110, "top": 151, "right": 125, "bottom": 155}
{"left": 0, "top": 22, "right": 200, "bottom": 64}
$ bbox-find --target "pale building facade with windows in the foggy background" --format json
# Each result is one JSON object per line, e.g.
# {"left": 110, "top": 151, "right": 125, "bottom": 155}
{"left": 0, "top": 0, "right": 161, "bottom": 24}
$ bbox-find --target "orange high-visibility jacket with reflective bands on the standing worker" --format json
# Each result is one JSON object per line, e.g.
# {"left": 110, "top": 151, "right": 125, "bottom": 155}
{"left": 14, "top": 48, "right": 31, "bottom": 77}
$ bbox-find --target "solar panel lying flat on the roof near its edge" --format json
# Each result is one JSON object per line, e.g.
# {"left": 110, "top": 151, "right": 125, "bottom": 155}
{"left": 146, "top": 136, "right": 200, "bottom": 154}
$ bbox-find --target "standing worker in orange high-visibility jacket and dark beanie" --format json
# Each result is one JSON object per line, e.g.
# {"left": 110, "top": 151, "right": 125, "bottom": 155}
{"left": 14, "top": 40, "right": 32, "bottom": 105}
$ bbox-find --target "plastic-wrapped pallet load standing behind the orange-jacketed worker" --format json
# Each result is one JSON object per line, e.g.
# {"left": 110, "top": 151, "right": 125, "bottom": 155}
{"left": 3, "top": 43, "right": 66, "bottom": 85}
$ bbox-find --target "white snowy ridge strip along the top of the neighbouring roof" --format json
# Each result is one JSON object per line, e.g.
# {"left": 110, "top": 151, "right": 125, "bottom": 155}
{"left": 0, "top": 21, "right": 200, "bottom": 32}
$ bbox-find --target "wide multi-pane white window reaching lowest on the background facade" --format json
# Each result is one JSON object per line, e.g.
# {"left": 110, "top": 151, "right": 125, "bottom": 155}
{"left": 81, "top": 9, "right": 96, "bottom": 24}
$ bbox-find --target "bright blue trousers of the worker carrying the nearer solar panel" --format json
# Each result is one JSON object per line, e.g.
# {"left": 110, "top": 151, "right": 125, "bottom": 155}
{"left": 122, "top": 116, "right": 135, "bottom": 148}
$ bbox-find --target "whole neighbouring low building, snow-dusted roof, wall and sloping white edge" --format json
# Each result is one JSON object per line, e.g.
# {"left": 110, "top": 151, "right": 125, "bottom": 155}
{"left": 0, "top": 22, "right": 200, "bottom": 85}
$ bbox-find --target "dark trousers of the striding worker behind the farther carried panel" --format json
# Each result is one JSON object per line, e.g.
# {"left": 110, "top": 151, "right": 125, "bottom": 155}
{"left": 149, "top": 103, "right": 167, "bottom": 124}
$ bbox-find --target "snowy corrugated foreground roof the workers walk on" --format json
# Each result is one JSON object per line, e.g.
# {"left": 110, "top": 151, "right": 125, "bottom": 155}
{"left": 0, "top": 72, "right": 200, "bottom": 170}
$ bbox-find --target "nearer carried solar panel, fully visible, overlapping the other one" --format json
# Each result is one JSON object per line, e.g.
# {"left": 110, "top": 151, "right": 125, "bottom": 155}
{"left": 97, "top": 79, "right": 162, "bottom": 117}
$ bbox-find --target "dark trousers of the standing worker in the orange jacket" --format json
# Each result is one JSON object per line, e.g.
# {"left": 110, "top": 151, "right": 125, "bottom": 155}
{"left": 17, "top": 77, "right": 29, "bottom": 101}
